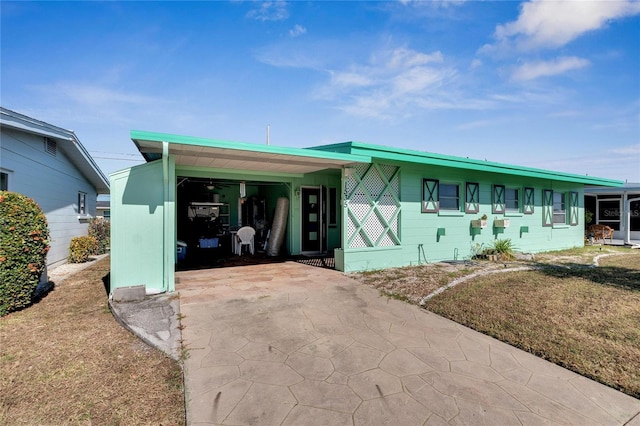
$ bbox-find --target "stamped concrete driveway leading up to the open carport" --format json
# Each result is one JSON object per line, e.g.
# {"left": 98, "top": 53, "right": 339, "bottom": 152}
{"left": 176, "top": 262, "right": 640, "bottom": 425}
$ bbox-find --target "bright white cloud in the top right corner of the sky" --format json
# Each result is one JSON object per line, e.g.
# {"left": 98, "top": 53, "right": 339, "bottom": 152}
{"left": 489, "top": 0, "right": 640, "bottom": 50}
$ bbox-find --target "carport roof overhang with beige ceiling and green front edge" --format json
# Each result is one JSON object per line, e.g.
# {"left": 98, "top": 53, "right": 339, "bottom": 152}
{"left": 131, "top": 131, "right": 371, "bottom": 174}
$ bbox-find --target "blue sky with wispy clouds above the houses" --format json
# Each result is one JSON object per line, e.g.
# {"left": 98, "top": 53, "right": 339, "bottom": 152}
{"left": 0, "top": 0, "right": 640, "bottom": 182}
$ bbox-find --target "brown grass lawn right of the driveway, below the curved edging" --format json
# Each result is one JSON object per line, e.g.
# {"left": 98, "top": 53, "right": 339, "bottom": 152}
{"left": 425, "top": 249, "right": 640, "bottom": 398}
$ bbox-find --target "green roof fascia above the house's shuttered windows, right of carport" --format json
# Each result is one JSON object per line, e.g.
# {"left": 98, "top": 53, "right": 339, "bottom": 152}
{"left": 310, "top": 142, "right": 624, "bottom": 187}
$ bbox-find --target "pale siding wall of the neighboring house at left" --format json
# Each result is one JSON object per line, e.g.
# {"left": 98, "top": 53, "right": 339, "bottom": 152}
{"left": 0, "top": 128, "right": 97, "bottom": 268}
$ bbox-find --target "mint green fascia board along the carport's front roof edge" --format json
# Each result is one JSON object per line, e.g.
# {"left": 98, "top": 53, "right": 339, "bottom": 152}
{"left": 131, "top": 130, "right": 371, "bottom": 163}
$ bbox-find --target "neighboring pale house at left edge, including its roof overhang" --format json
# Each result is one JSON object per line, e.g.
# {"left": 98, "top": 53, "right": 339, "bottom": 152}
{"left": 0, "top": 107, "right": 109, "bottom": 268}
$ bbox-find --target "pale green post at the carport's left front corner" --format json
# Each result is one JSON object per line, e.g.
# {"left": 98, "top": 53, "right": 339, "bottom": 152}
{"left": 162, "top": 142, "right": 176, "bottom": 292}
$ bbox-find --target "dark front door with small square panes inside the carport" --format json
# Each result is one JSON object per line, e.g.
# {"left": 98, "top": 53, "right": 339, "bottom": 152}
{"left": 301, "top": 186, "right": 327, "bottom": 253}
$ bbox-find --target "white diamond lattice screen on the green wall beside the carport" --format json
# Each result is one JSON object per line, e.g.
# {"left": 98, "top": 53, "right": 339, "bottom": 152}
{"left": 344, "top": 164, "right": 400, "bottom": 248}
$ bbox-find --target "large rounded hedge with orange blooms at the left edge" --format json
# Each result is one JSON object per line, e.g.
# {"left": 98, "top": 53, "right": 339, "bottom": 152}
{"left": 0, "top": 191, "right": 49, "bottom": 316}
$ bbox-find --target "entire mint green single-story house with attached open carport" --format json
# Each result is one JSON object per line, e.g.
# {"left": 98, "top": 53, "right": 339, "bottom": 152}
{"left": 110, "top": 131, "right": 622, "bottom": 293}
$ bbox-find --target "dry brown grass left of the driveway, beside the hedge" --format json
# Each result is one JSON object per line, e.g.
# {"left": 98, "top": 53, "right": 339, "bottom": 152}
{"left": 0, "top": 258, "right": 184, "bottom": 425}
